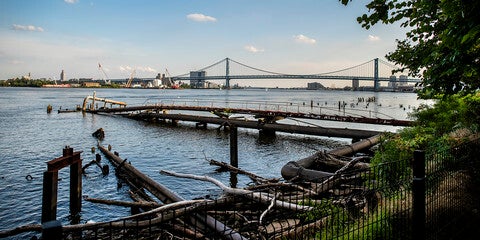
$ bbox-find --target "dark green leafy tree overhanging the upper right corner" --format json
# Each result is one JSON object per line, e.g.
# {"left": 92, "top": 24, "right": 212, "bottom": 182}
{"left": 339, "top": 0, "right": 480, "bottom": 98}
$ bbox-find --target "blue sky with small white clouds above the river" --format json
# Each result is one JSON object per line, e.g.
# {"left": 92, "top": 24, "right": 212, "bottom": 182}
{"left": 0, "top": 0, "right": 405, "bottom": 86}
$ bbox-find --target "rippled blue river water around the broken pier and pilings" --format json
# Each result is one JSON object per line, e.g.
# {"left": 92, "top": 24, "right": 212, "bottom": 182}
{"left": 0, "top": 88, "right": 428, "bottom": 238}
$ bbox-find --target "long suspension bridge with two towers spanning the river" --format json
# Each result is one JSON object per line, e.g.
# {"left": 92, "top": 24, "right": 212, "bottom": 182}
{"left": 164, "top": 58, "right": 419, "bottom": 90}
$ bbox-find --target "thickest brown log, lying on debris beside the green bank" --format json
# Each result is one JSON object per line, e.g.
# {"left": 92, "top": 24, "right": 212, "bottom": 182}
{"left": 281, "top": 134, "right": 381, "bottom": 181}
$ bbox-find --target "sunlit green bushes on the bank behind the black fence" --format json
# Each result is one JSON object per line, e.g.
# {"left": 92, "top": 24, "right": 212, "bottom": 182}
{"left": 371, "top": 93, "right": 480, "bottom": 194}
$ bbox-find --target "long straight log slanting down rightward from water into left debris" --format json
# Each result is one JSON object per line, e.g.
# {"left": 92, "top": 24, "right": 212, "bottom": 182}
{"left": 98, "top": 143, "right": 246, "bottom": 240}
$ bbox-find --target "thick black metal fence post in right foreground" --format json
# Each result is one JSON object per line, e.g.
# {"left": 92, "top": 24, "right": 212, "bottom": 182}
{"left": 412, "top": 150, "right": 426, "bottom": 240}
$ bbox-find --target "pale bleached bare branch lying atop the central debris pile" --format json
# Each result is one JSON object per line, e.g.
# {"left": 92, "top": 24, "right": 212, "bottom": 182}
{"left": 160, "top": 170, "right": 312, "bottom": 211}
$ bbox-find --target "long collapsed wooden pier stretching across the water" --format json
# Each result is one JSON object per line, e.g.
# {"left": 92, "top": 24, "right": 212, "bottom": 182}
{"left": 83, "top": 94, "right": 411, "bottom": 140}
